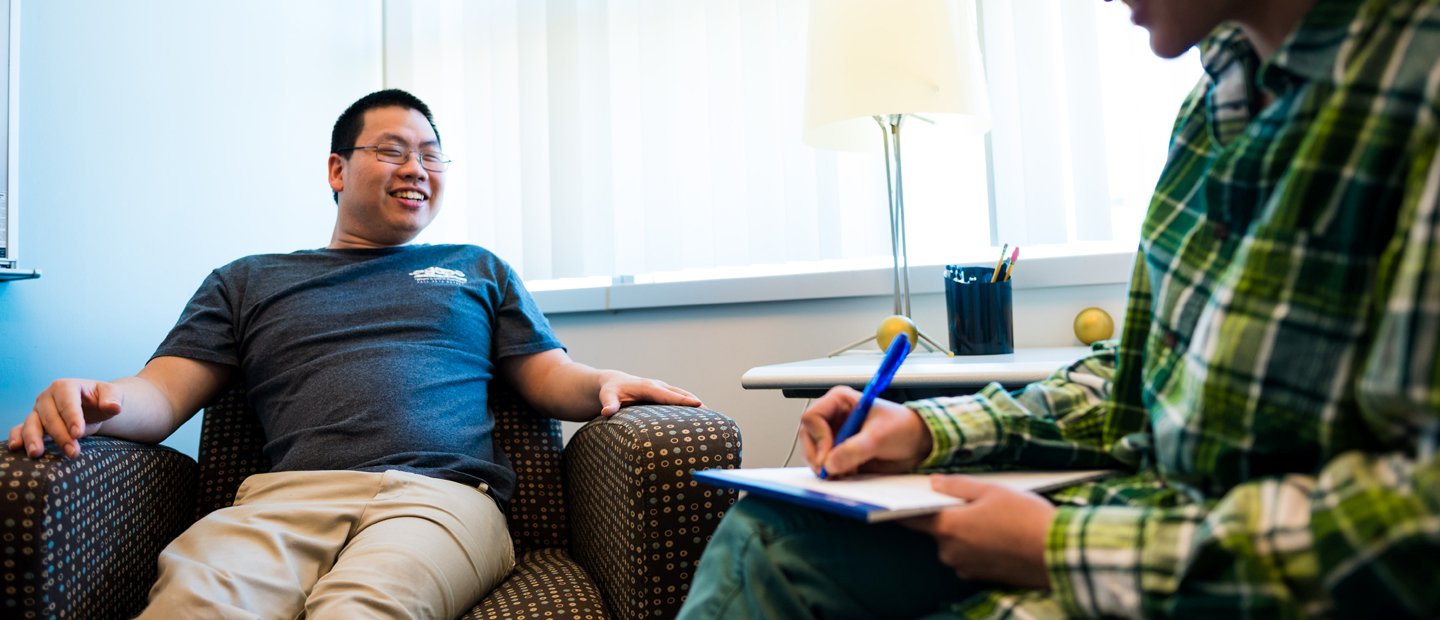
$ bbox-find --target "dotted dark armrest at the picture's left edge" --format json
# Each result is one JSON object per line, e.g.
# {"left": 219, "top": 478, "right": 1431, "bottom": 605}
{"left": 0, "top": 437, "right": 196, "bottom": 619}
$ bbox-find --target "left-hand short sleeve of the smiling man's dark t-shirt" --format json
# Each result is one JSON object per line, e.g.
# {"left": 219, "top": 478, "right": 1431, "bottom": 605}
{"left": 151, "top": 270, "right": 239, "bottom": 367}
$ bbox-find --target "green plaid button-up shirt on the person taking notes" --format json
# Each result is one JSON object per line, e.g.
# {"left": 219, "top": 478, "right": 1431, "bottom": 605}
{"left": 909, "top": 0, "right": 1440, "bottom": 617}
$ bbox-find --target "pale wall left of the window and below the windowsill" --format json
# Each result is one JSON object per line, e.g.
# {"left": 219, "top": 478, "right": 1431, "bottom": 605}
{"left": 0, "top": 0, "right": 1123, "bottom": 466}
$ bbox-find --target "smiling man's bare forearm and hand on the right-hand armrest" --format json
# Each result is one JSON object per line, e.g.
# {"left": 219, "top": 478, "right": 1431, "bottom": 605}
{"left": 500, "top": 348, "right": 701, "bottom": 421}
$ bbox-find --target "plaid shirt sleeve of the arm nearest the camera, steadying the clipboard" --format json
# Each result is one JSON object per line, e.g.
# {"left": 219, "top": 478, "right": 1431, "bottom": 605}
{"left": 1045, "top": 132, "right": 1440, "bottom": 617}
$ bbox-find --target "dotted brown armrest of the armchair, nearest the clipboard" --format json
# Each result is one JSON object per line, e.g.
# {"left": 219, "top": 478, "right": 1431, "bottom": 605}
{"left": 564, "top": 406, "right": 740, "bottom": 619}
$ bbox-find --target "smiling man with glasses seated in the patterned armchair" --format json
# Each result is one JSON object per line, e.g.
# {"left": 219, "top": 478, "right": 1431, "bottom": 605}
{"left": 9, "top": 91, "right": 700, "bottom": 620}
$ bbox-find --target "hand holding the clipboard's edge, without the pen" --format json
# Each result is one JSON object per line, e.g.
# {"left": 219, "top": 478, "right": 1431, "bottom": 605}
{"left": 900, "top": 475, "right": 1056, "bottom": 590}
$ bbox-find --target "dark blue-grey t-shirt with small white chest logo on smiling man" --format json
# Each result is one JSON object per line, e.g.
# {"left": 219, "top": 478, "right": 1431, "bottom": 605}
{"left": 156, "top": 245, "right": 560, "bottom": 502}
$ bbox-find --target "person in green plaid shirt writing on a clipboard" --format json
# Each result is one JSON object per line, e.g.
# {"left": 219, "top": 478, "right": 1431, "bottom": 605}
{"left": 681, "top": 0, "right": 1440, "bottom": 617}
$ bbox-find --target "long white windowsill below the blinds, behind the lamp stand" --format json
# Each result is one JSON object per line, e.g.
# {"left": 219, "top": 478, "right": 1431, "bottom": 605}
{"left": 533, "top": 245, "right": 1135, "bottom": 315}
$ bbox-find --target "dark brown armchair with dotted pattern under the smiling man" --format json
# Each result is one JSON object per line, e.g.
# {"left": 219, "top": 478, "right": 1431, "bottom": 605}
{"left": 0, "top": 386, "right": 740, "bottom": 619}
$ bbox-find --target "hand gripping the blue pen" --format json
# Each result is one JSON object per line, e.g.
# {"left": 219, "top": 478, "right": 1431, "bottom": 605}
{"left": 801, "top": 386, "right": 932, "bottom": 478}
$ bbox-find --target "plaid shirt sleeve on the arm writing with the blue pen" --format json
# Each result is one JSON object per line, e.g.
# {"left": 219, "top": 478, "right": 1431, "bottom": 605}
{"left": 906, "top": 341, "right": 1119, "bottom": 469}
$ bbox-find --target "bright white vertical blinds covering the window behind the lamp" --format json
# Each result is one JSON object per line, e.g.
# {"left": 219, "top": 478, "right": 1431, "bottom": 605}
{"left": 383, "top": 0, "right": 1194, "bottom": 281}
